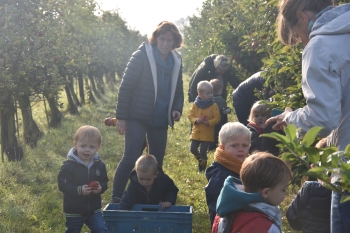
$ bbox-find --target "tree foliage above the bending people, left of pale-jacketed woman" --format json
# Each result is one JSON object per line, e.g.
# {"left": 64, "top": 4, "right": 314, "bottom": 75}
{"left": 182, "top": 0, "right": 350, "bottom": 109}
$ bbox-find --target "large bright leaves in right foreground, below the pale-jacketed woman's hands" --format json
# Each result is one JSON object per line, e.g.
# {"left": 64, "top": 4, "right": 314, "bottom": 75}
{"left": 261, "top": 125, "right": 350, "bottom": 201}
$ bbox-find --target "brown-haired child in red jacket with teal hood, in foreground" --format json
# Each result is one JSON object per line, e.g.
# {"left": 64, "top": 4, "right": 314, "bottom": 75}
{"left": 212, "top": 152, "right": 292, "bottom": 233}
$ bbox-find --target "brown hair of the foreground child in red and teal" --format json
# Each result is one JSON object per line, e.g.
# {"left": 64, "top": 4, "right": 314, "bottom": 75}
{"left": 240, "top": 152, "right": 292, "bottom": 193}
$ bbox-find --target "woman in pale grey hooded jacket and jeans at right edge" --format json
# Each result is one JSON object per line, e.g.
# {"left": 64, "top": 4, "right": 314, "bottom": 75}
{"left": 266, "top": 0, "right": 350, "bottom": 233}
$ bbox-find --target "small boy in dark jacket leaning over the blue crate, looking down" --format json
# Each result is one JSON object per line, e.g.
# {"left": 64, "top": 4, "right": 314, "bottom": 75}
{"left": 119, "top": 154, "right": 179, "bottom": 210}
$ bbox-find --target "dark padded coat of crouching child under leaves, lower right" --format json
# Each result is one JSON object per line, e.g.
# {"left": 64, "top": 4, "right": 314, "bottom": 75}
{"left": 286, "top": 181, "right": 332, "bottom": 233}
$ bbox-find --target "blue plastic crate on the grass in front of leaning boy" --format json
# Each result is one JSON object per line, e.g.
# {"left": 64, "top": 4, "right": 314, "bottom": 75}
{"left": 103, "top": 203, "right": 192, "bottom": 233}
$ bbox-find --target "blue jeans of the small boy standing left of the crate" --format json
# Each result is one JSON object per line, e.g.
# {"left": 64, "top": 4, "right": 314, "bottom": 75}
{"left": 65, "top": 212, "right": 108, "bottom": 233}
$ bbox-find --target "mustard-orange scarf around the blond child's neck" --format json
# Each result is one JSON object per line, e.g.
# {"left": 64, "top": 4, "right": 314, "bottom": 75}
{"left": 214, "top": 148, "right": 244, "bottom": 174}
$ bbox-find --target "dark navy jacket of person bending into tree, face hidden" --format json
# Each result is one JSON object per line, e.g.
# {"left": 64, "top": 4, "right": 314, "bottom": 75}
{"left": 232, "top": 71, "right": 265, "bottom": 125}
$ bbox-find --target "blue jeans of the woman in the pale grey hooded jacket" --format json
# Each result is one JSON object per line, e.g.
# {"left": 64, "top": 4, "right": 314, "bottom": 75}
{"left": 331, "top": 187, "right": 350, "bottom": 233}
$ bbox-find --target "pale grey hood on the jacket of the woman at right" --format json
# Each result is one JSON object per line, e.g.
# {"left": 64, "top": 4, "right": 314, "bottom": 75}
{"left": 310, "top": 4, "right": 350, "bottom": 39}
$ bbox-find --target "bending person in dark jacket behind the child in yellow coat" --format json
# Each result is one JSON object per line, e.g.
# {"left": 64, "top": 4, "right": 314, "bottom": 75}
{"left": 188, "top": 54, "right": 239, "bottom": 102}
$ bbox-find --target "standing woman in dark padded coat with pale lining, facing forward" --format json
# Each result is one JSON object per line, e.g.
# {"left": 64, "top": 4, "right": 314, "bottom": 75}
{"left": 112, "top": 21, "right": 184, "bottom": 203}
